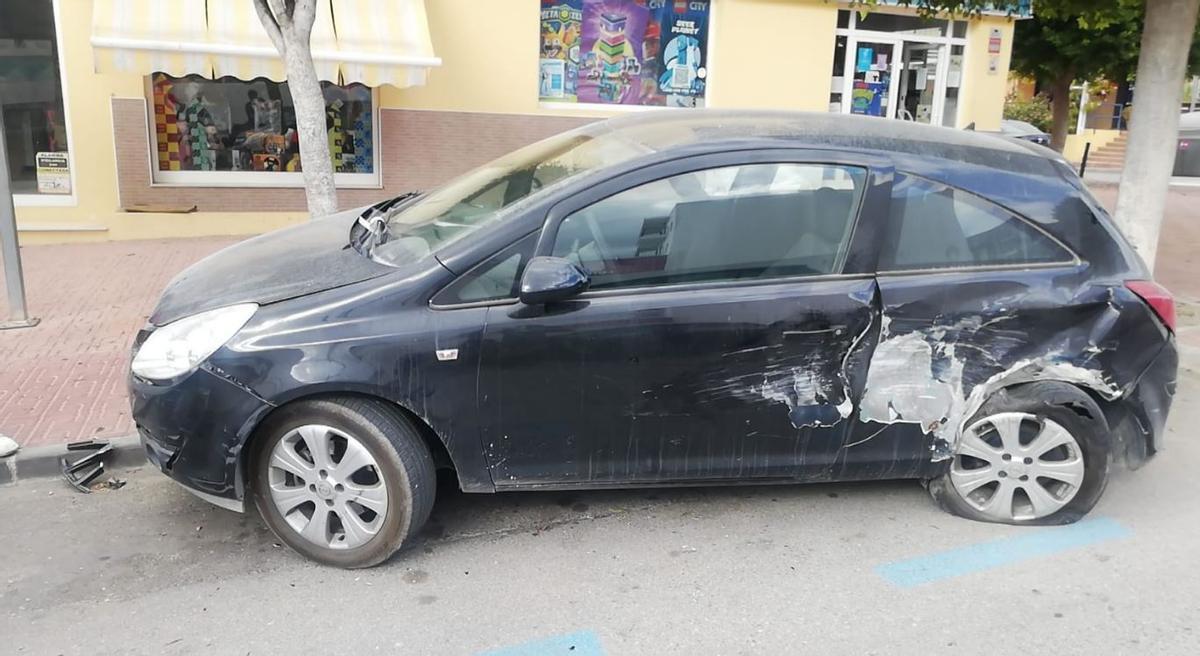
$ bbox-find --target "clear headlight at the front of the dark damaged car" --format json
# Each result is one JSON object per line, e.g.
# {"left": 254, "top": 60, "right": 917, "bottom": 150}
{"left": 132, "top": 303, "right": 258, "bottom": 380}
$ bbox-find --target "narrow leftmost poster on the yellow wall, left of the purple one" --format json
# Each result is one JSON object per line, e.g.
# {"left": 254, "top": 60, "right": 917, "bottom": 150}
{"left": 538, "top": 0, "right": 583, "bottom": 102}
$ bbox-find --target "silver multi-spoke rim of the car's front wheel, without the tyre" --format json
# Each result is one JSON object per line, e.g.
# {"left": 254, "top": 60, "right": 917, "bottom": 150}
{"left": 268, "top": 425, "right": 388, "bottom": 549}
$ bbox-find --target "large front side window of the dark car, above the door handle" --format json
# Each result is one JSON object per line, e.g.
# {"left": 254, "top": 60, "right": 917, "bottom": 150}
{"left": 553, "top": 163, "right": 866, "bottom": 289}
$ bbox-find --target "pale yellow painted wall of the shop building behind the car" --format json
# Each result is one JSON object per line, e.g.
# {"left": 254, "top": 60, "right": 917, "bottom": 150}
{"left": 17, "top": 0, "right": 1013, "bottom": 243}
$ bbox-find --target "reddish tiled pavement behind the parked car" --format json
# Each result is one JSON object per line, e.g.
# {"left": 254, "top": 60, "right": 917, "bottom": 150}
{"left": 0, "top": 187, "right": 1200, "bottom": 446}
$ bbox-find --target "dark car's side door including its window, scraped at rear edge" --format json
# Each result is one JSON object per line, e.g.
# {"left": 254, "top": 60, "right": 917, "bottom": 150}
{"left": 478, "top": 152, "right": 889, "bottom": 487}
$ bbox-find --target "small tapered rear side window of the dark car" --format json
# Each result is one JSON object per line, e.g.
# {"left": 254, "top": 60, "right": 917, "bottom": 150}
{"left": 880, "top": 175, "right": 1073, "bottom": 271}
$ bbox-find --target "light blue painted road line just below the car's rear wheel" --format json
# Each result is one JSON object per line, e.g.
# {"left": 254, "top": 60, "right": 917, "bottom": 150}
{"left": 875, "top": 517, "right": 1130, "bottom": 588}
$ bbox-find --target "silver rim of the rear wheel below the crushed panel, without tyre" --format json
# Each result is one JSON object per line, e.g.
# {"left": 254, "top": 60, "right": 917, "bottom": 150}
{"left": 950, "top": 413, "right": 1085, "bottom": 522}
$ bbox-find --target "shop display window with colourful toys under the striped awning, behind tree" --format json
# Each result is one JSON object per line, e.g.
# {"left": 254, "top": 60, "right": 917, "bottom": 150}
{"left": 150, "top": 73, "right": 378, "bottom": 186}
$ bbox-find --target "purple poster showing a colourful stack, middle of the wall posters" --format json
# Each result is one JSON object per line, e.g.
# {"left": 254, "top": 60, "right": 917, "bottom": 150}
{"left": 578, "top": 0, "right": 650, "bottom": 104}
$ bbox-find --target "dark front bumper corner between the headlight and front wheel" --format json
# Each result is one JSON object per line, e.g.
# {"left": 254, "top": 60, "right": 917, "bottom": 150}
{"left": 128, "top": 366, "right": 271, "bottom": 510}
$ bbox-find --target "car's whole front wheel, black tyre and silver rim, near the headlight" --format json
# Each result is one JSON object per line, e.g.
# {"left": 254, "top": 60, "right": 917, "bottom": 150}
{"left": 250, "top": 397, "right": 437, "bottom": 568}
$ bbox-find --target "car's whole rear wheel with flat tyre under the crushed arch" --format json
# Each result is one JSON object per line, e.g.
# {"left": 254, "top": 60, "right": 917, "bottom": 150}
{"left": 929, "top": 381, "right": 1112, "bottom": 525}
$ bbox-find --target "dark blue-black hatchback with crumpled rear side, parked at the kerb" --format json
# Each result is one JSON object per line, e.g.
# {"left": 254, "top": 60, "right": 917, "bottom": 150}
{"left": 130, "top": 112, "right": 1176, "bottom": 567}
